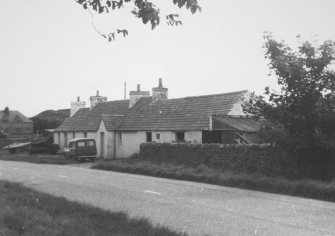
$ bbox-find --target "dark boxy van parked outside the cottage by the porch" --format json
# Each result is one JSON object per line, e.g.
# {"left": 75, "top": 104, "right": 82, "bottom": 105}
{"left": 64, "top": 138, "right": 97, "bottom": 161}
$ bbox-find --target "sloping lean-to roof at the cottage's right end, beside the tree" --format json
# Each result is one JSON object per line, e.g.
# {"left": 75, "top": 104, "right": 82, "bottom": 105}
{"left": 213, "top": 117, "right": 262, "bottom": 132}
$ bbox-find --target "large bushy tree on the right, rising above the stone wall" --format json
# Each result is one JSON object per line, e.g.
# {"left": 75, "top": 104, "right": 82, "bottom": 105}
{"left": 244, "top": 34, "right": 335, "bottom": 177}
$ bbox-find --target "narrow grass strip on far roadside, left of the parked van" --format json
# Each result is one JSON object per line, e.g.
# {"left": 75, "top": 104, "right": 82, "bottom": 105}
{"left": 0, "top": 152, "right": 78, "bottom": 165}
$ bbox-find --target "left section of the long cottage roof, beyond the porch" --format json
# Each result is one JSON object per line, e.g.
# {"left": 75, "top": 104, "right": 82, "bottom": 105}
{"left": 56, "top": 100, "right": 129, "bottom": 132}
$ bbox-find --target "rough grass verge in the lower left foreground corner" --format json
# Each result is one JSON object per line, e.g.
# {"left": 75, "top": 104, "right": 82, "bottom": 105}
{"left": 0, "top": 181, "right": 185, "bottom": 236}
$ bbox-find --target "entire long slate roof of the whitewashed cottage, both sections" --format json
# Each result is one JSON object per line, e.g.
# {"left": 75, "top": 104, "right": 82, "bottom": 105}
{"left": 56, "top": 90, "right": 248, "bottom": 132}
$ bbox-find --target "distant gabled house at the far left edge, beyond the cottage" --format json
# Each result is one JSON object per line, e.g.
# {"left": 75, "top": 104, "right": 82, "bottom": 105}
{"left": 0, "top": 108, "right": 33, "bottom": 138}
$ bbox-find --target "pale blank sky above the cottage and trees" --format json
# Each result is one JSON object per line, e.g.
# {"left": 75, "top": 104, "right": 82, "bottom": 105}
{"left": 0, "top": 0, "right": 335, "bottom": 117}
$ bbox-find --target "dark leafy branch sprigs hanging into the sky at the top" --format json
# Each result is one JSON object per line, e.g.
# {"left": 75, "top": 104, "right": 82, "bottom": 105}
{"left": 76, "top": 0, "right": 201, "bottom": 41}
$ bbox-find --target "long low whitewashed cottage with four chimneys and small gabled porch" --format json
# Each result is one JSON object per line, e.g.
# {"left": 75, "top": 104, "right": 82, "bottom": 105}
{"left": 54, "top": 79, "right": 261, "bottom": 158}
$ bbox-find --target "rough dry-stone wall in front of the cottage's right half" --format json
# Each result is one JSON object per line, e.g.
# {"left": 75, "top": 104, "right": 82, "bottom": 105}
{"left": 139, "top": 143, "right": 287, "bottom": 176}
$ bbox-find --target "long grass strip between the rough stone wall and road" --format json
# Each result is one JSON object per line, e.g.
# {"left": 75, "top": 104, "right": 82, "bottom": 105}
{"left": 92, "top": 158, "right": 335, "bottom": 202}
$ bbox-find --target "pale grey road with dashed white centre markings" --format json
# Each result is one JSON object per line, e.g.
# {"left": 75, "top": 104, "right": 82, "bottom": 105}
{"left": 0, "top": 161, "right": 335, "bottom": 236}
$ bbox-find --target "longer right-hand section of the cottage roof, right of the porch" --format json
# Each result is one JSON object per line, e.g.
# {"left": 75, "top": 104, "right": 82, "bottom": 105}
{"left": 119, "top": 90, "right": 248, "bottom": 131}
